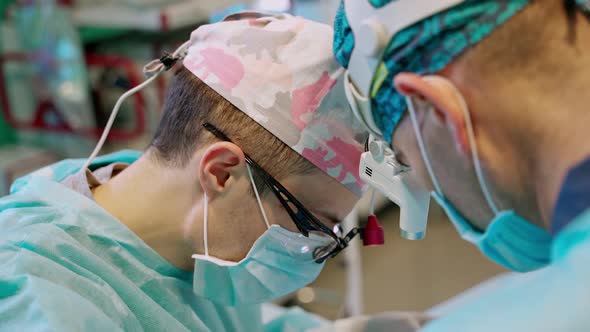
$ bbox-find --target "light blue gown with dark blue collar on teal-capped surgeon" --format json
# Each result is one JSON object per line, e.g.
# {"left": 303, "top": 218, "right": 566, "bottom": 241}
{"left": 421, "top": 159, "right": 590, "bottom": 332}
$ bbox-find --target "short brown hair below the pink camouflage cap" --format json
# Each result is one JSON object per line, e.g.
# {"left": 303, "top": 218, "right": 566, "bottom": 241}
{"left": 150, "top": 66, "right": 317, "bottom": 192}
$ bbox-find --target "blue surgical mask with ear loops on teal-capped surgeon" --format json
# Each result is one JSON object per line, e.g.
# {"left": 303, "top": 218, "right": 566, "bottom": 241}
{"left": 406, "top": 76, "right": 552, "bottom": 272}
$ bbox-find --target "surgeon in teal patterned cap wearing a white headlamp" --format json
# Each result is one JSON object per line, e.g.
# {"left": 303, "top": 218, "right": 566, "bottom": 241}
{"left": 334, "top": 0, "right": 590, "bottom": 332}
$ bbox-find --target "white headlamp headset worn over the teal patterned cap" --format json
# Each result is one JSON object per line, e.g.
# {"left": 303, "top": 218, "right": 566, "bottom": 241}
{"left": 343, "top": 0, "right": 462, "bottom": 240}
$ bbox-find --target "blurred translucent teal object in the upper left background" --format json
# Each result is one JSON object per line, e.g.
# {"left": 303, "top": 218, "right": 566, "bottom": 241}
{"left": 8, "top": 0, "right": 94, "bottom": 130}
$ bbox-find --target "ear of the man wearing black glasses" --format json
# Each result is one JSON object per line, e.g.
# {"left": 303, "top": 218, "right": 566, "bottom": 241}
{"left": 199, "top": 142, "right": 246, "bottom": 199}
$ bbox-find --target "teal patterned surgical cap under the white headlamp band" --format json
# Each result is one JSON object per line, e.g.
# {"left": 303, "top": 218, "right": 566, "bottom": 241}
{"left": 334, "top": 0, "right": 536, "bottom": 143}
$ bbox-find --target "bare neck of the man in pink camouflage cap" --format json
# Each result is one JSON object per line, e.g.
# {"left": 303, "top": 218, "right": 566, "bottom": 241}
{"left": 93, "top": 154, "right": 201, "bottom": 271}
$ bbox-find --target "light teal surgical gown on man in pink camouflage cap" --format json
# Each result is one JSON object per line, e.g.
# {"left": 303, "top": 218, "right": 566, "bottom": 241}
{"left": 0, "top": 151, "right": 324, "bottom": 332}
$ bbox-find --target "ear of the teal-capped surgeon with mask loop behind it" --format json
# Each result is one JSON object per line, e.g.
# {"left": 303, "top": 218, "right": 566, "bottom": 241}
{"left": 394, "top": 73, "right": 471, "bottom": 154}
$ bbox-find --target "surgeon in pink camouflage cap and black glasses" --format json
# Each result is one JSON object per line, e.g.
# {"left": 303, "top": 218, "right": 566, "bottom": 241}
{"left": 0, "top": 13, "right": 366, "bottom": 331}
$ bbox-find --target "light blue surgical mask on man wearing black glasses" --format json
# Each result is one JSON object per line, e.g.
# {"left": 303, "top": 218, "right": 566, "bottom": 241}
{"left": 192, "top": 166, "right": 331, "bottom": 306}
